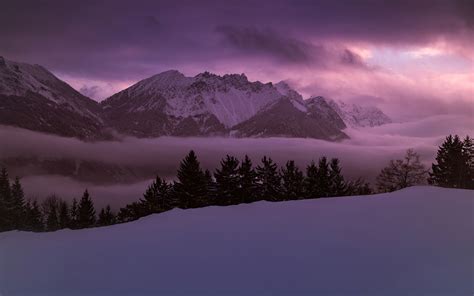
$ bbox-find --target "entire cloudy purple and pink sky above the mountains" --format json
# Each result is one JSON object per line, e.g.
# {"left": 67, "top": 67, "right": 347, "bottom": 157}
{"left": 0, "top": 0, "right": 474, "bottom": 120}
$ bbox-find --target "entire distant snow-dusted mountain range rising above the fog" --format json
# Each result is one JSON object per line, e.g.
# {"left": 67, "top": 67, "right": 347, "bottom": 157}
{"left": 0, "top": 57, "right": 390, "bottom": 141}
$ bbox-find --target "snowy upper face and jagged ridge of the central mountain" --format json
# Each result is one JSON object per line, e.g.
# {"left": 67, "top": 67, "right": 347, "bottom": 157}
{"left": 103, "top": 70, "right": 284, "bottom": 128}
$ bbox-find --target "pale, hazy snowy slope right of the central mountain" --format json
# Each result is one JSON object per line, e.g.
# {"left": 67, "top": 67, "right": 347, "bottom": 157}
{"left": 318, "top": 96, "right": 392, "bottom": 127}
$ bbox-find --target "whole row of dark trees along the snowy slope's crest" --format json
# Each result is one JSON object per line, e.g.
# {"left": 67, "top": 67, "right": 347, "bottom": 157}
{"left": 0, "top": 135, "right": 474, "bottom": 232}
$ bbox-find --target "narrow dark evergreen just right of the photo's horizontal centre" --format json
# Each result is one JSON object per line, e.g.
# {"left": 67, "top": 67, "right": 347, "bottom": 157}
{"left": 237, "top": 155, "right": 258, "bottom": 203}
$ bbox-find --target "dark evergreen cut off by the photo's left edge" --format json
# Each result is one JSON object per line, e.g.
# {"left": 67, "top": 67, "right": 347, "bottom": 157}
{"left": 0, "top": 168, "right": 15, "bottom": 232}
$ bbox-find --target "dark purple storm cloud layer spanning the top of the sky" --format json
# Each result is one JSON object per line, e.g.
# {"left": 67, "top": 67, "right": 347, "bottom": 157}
{"left": 0, "top": 0, "right": 474, "bottom": 79}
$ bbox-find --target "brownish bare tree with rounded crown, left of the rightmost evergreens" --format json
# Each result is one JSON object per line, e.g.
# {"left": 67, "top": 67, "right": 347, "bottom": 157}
{"left": 376, "top": 149, "right": 428, "bottom": 192}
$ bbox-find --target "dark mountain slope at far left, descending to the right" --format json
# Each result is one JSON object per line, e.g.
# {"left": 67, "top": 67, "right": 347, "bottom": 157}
{"left": 0, "top": 57, "right": 105, "bottom": 139}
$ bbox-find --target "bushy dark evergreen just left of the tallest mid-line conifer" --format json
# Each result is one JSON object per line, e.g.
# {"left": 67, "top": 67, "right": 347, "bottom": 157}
{"left": 140, "top": 176, "right": 174, "bottom": 214}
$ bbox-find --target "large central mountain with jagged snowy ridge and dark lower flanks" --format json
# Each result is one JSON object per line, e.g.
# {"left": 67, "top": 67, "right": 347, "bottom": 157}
{"left": 102, "top": 70, "right": 346, "bottom": 140}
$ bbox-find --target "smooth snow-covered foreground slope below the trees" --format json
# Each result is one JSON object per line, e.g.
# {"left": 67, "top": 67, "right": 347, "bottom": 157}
{"left": 0, "top": 187, "right": 474, "bottom": 296}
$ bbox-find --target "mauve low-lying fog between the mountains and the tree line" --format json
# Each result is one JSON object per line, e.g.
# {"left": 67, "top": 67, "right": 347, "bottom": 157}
{"left": 0, "top": 115, "right": 474, "bottom": 207}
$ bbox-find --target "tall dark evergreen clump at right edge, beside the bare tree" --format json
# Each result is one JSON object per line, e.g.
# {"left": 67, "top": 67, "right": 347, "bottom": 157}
{"left": 428, "top": 135, "right": 474, "bottom": 189}
